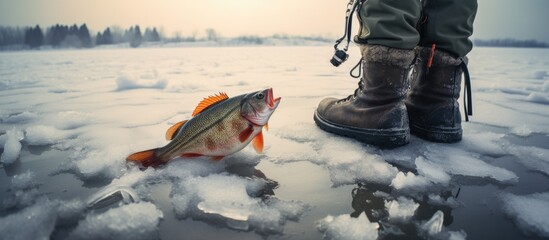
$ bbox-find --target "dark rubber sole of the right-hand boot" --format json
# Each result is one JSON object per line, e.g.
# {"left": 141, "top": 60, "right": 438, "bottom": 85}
{"left": 410, "top": 123, "right": 463, "bottom": 143}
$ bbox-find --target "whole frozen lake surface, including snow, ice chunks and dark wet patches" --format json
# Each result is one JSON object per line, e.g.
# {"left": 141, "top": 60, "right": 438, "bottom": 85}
{"left": 0, "top": 46, "right": 549, "bottom": 239}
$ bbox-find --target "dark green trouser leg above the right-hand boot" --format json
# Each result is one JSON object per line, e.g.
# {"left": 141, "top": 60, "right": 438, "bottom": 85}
{"left": 419, "top": 0, "right": 477, "bottom": 57}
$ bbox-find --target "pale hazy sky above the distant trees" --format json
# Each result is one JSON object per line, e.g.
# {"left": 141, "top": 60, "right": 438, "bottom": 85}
{"left": 0, "top": 0, "right": 549, "bottom": 42}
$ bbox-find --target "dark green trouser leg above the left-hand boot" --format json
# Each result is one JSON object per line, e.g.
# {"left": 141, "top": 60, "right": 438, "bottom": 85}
{"left": 355, "top": 0, "right": 421, "bottom": 49}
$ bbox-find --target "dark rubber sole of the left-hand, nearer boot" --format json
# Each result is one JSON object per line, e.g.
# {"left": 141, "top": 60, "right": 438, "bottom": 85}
{"left": 314, "top": 111, "right": 410, "bottom": 148}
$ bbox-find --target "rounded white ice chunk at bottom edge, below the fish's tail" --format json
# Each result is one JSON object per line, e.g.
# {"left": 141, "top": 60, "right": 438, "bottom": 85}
{"left": 69, "top": 202, "right": 163, "bottom": 239}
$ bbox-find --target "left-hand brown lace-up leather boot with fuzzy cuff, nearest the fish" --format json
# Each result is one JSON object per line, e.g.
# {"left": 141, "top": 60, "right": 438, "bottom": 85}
{"left": 314, "top": 45, "right": 415, "bottom": 147}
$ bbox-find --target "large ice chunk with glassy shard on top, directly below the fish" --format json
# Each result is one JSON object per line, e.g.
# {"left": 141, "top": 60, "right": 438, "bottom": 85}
{"left": 172, "top": 174, "right": 308, "bottom": 233}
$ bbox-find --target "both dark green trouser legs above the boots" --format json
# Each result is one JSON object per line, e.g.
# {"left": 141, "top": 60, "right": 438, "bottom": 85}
{"left": 355, "top": 0, "right": 477, "bottom": 57}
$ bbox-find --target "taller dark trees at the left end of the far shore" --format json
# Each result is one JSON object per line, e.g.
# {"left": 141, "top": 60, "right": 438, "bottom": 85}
{"left": 0, "top": 24, "right": 161, "bottom": 48}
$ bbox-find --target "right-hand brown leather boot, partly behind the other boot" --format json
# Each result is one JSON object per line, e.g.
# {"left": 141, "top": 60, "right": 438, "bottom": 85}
{"left": 406, "top": 48, "right": 463, "bottom": 143}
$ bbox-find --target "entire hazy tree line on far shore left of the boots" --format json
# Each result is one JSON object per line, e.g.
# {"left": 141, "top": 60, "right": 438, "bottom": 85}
{"left": 0, "top": 24, "right": 333, "bottom": 50}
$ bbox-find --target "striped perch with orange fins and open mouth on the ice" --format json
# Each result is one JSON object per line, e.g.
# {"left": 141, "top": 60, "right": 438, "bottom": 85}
{"left": 126, "top": 88, "right": 281, "bottom": 168}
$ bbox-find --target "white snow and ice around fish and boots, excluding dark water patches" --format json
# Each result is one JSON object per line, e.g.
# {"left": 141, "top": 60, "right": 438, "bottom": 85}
{"left": 0, "top": 47, "right": 549, "bottom": 239}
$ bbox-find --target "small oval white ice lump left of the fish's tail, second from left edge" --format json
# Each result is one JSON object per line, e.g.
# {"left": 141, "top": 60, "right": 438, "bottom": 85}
{"left": 25, "top": 125, "right": 69, "bottom": 146}
